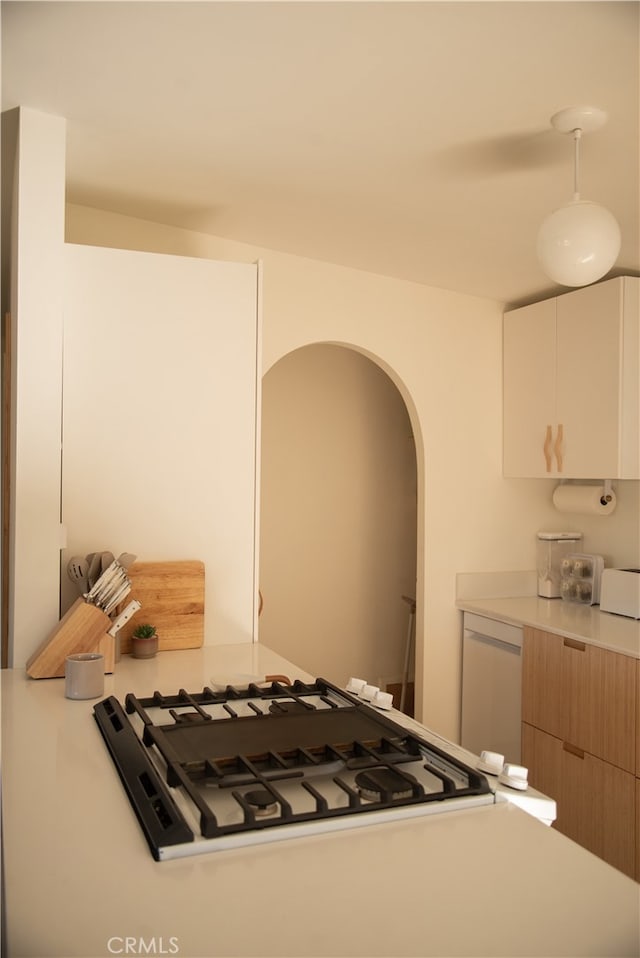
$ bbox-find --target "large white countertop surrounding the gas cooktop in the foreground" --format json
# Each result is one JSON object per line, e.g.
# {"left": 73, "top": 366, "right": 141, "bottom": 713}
{"left": 2, "top": 645, "right": 640, "bottom": 958}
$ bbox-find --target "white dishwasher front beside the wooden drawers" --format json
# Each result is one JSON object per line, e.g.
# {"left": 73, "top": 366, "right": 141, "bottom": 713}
{"left": 460, "top": 612, "right": 522, "bottom": 764}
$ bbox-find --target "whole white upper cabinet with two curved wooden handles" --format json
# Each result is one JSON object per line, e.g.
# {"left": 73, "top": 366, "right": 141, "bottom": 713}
{"left": 504, "top": 277, "right": 640, "bottom": 479}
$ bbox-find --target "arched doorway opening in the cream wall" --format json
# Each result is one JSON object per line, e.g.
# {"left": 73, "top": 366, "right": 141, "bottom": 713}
{"left": 260, "top": 344, "right": 417, "bottom": 711}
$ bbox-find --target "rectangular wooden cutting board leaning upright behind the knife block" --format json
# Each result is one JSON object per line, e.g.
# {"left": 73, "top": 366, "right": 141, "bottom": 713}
{"left": 120, "top": 559, "right": 204, "bottom": 652}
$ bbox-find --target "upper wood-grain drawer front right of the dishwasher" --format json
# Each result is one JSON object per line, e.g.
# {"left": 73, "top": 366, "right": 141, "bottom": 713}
{"left": 522, "top": 629, "right": 640, "bottom": 774}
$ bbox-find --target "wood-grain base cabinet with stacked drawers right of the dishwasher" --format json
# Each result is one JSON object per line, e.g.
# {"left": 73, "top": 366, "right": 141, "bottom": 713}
{"left": 522, "top": 628, "right": 640, "bottom": 881}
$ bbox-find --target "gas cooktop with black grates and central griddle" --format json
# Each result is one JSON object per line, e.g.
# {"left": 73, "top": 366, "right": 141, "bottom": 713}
{"left": 93, "top": 679, "right": 555, "bottom": 861}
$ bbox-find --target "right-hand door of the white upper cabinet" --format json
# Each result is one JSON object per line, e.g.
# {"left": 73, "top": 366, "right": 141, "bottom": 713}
{"left": 556, "top": 280, "right": 622, "bottom": 479}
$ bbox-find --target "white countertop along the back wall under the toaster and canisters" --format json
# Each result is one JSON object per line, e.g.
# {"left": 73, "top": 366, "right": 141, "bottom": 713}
{"left": 456, "top": 595, "right": 640, "bottom": 658}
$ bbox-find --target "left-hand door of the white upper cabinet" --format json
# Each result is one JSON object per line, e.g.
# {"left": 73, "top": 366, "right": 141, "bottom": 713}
{"left": 503, "top": 299, "right": 556, "bottom": 478}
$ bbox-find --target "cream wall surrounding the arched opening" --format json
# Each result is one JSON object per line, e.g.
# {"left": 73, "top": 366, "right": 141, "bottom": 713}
{"left": 67, "top": 206, "right": 638, "bottom": 737}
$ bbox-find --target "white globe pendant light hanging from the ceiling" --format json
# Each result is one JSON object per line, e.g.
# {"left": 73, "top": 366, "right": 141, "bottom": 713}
{"left": 537, "top": 106, "right": 620, "bottom": 286}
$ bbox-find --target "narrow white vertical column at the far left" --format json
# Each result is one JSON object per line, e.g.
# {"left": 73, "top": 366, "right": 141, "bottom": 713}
{"left": 9, "top": 109, "right": 66, "bottom": 667}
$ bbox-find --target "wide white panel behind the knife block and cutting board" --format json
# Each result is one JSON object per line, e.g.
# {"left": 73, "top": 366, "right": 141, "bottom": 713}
{"left": 62, "top": 245, "right": 259, "bottom": 645}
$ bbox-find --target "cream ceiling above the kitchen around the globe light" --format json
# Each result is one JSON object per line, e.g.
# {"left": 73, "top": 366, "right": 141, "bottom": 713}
{"left": 2, "top": 0, "right": 640, "bottom": 303}
